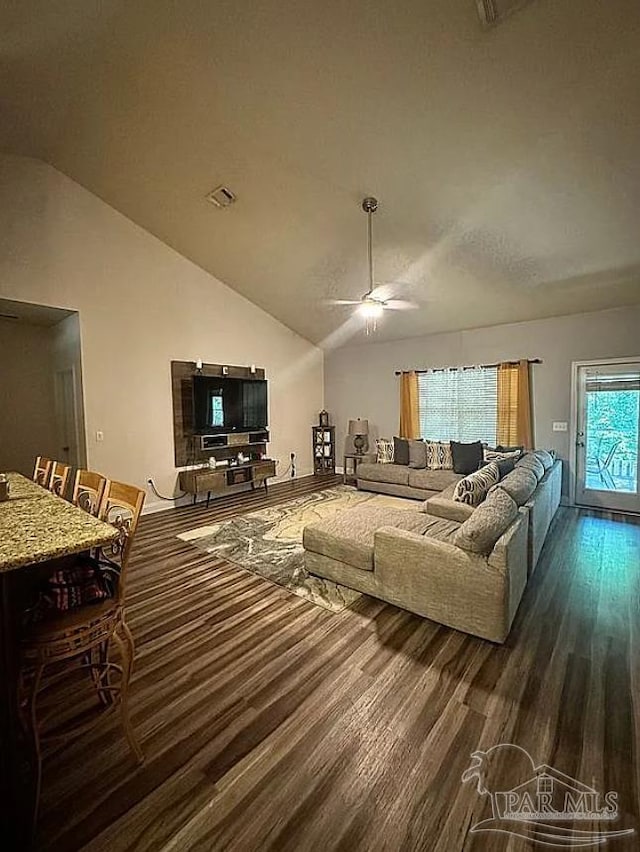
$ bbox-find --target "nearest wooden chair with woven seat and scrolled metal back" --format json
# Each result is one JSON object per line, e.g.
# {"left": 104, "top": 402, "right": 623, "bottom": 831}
{"left": 19, "top": 482, "right": 145, "bottom": 829}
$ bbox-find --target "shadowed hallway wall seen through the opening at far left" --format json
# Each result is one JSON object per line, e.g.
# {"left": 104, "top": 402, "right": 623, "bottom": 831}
{"left": 0, "top": 320, "right": 56, "bottom": 476}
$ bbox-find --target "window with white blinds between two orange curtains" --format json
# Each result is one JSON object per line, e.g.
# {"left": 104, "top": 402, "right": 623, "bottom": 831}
{"left": 418, "top": 367, "right": 498, "bottom": 446}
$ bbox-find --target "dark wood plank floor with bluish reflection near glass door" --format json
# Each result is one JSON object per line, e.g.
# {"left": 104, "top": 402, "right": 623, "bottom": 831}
{"left": 39, "top": 480, "right": 640, "bottom": 852}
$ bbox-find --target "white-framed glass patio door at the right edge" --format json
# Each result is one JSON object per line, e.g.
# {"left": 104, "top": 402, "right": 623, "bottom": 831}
{"left": 573, "top": 358, "right": 640, "bottom": 513}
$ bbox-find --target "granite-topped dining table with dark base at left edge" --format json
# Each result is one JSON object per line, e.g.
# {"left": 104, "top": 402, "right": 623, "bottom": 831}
{"left": 0, "top": 472, "right": 118, "bottom": 850}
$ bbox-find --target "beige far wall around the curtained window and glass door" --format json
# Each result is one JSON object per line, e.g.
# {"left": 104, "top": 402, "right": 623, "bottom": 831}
{"left": 325, "top": 306, "right": 640, "bottom": 487}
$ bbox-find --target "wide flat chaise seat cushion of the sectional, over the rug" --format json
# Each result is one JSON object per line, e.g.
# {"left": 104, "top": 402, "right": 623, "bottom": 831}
{"left": 302, "top": 506, "right": 432, "bottom": 571}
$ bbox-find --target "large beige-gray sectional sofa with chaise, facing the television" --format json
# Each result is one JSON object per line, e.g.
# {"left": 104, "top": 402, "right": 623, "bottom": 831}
{"left": 303, "top": 453, "right": 562, "bottom": 643}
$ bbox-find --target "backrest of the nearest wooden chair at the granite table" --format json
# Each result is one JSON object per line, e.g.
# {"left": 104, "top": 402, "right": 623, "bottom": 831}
{"left": 98, "top": 480, "right": 146, "bottom": 603}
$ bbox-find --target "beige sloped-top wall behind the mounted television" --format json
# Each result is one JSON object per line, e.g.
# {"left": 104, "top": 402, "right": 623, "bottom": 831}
{"left": 0, "top": 157, "right": 323, "bottom": 508}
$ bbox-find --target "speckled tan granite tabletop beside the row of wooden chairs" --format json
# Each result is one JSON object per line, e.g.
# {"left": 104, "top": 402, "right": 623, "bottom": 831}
{"left": 0, "top": 474, "right": 118, "bottom": 572}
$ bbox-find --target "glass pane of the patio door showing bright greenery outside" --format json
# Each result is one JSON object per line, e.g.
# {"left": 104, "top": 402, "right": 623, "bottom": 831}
{"left": 585, "top": 390, "right": 640, "bottom": 494}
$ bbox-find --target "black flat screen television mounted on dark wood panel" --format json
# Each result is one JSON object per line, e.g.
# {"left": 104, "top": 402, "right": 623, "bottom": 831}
{"left": 193, "top": 376, "right": 269, "bottom": 435}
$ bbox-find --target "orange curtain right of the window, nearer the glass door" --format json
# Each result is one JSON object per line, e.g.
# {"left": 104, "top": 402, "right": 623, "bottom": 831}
{"left": 497, "top": 361, "right": 533, "bottom": 449}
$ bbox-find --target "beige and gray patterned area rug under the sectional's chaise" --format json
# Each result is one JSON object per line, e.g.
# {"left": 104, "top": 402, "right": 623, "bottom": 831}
{"left": 178, "top": 485, "right": 416, "bottom": 612}
